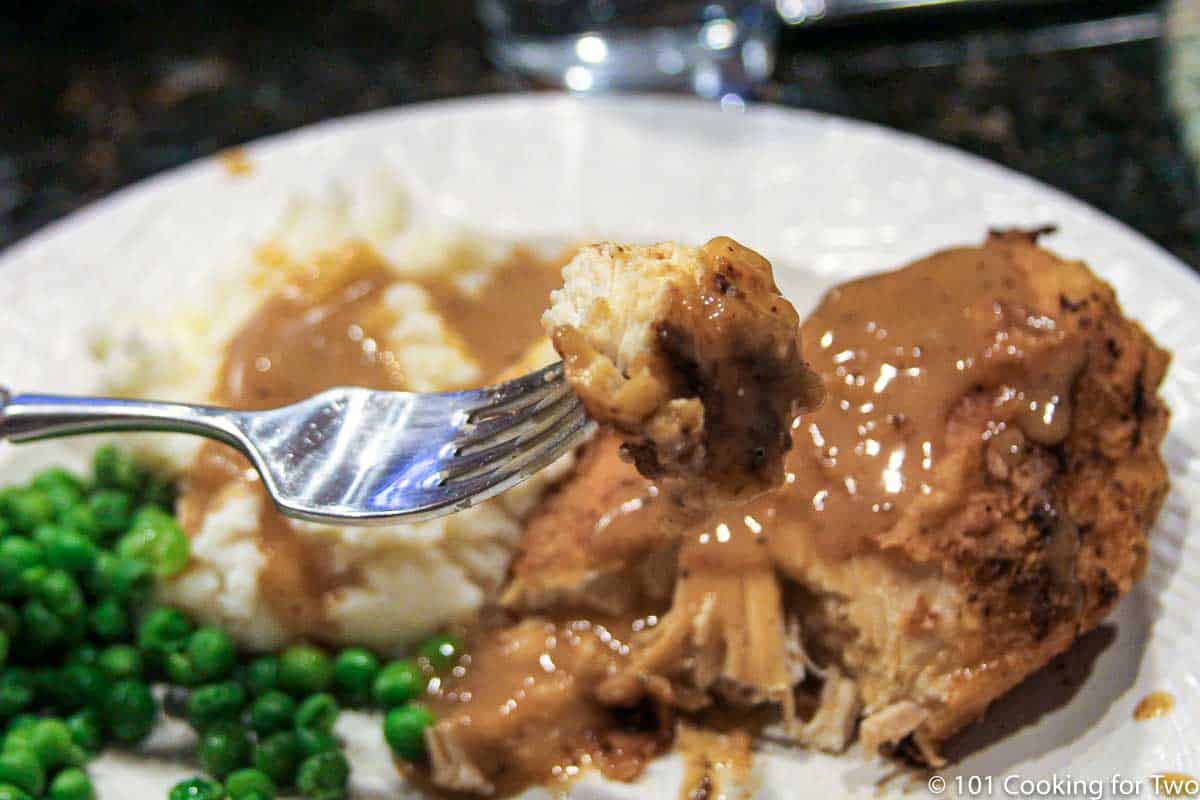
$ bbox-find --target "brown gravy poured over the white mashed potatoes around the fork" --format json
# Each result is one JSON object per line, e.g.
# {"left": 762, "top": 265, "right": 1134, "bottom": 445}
{"left": 180, "top": 245, "right": 558, "bottom": 639}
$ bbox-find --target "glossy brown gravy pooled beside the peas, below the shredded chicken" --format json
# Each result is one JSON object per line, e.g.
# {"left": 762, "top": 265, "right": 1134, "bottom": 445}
{"left": 428, "top": 614, "right": 672, "bottom": 796}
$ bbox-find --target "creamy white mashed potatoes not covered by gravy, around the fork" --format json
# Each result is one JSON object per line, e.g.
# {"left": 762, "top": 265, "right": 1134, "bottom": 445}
{"left": 92, "top": 178, "right": 568, "bottom": 651}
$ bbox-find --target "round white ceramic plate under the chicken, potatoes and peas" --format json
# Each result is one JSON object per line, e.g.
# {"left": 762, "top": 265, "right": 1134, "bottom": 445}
{"left": 0, "top": 96, "right": 1200, "bottom": 799}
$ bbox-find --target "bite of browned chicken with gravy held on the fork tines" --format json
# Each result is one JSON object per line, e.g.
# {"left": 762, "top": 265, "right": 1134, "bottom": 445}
{"left": 542, "top": 236, "right": 821, "bottom": 506}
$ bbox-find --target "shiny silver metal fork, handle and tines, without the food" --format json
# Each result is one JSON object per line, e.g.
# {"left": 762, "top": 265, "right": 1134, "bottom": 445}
{"left": 0, "top": 363, "right": 595, "bottom": 524}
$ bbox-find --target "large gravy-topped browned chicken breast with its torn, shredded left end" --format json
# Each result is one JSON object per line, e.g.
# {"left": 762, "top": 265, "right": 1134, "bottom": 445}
{"left": 424, "top": 231, "right": 1169, "bottom": 788}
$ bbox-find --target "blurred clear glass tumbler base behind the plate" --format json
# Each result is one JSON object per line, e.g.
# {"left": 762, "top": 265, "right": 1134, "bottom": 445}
{"left": 479, "top": 0, "right": 779, "bottom": 97}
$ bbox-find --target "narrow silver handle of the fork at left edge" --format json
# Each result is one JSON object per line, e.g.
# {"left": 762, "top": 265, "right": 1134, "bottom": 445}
{"left": 0, "top": 386, "right": 242, "bottom": 446}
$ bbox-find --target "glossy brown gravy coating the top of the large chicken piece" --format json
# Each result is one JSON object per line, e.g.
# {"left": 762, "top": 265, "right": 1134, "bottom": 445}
{"left": 686, "top": 251, "right": 1084, "bottom": 564}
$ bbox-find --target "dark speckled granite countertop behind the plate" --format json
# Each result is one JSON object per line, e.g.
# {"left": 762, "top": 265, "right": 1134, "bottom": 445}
{"left": 0, "top": 0, "right": 1200, "bottom": 266}
